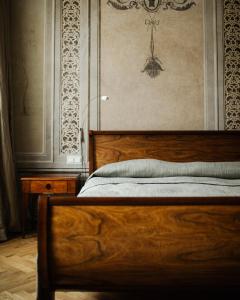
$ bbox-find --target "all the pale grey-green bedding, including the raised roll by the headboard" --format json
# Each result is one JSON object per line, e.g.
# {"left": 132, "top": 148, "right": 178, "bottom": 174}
{"left": 78, "top": 159, "right": 240, "bottom": 197}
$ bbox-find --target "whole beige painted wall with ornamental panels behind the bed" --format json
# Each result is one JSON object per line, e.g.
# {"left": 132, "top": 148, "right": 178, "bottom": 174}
{"left": 7, "top": 0, "right": 240, "bottom": 170}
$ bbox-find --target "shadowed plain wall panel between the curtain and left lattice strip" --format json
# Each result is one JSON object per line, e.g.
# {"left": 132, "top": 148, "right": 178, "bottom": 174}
{"left": 10, "top": 0, "right": 55, "bottom": 167}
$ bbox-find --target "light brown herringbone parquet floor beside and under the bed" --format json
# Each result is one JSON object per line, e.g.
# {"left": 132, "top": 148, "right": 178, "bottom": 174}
{"left": 0, "top": 237, "right": 104, "bottom": 300}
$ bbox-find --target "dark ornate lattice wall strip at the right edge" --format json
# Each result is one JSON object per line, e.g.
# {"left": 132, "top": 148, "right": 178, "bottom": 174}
{"left": 224, "top": 0, "right": 240, "bottom": 130}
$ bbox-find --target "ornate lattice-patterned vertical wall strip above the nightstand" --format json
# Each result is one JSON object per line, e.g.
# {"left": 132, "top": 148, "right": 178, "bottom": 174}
{"left": 60, "top": 0, "right": 81, "bottom": 154}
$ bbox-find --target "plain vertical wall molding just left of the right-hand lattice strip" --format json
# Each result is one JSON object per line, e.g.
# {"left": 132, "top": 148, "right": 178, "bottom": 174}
{"left": 204, "top": 0, "right": 224, "bottom": 130}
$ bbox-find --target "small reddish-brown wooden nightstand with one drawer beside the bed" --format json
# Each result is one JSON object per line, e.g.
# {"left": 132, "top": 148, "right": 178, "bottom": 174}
{"left": 21, "top": 174, "right": 80, "bottom": 237}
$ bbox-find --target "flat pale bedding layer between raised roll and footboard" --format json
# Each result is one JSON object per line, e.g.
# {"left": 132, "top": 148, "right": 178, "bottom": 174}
{"left": 78, "top": 177, "right": 240, "bottom": 197}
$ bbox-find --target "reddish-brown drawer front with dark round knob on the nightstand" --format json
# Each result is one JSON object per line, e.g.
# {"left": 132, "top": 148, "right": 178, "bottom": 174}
{"left": 30, "top": 180, "right": 67, "bottom": 193}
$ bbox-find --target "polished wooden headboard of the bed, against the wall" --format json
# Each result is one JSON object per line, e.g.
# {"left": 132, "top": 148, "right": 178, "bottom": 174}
{"left": 89, "top": 131, "right": 240, "bottom": 174}
